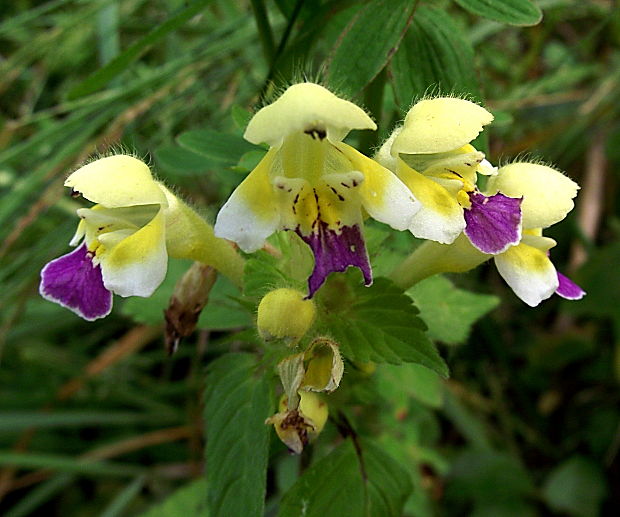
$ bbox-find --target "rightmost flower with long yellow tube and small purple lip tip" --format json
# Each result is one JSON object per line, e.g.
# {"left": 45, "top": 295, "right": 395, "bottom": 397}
{"left": 392, "top": 162, "right": 585, "bottom": 307}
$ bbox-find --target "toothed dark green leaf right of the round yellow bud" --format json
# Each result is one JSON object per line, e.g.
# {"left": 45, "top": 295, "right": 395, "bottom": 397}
{"left": 319, "top": 275, "right": 448, "bottom": 377}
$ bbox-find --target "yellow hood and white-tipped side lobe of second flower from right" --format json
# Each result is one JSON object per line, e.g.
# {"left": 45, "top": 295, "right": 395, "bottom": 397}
{"left": 375, "top": 97, "right": 496, "bottom": 247}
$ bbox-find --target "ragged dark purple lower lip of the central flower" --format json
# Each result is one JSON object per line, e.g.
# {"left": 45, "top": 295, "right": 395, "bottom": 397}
{"left": 296, "top": 221, "right": 372, "bottom": 298}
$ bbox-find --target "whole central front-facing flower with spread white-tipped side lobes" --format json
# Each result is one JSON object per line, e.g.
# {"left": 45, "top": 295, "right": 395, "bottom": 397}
{"left": 215, "top": 83, "right": 419, "bottom": 297}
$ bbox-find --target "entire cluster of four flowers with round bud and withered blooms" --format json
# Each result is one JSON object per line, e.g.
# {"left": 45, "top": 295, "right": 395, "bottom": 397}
{"left": 40, "top": 79, "right": 585, "bottom": 453}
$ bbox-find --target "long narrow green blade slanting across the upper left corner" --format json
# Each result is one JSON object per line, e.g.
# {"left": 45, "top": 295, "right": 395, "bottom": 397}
{"left": 67, "top": 0, "right": 211, "bottom": 100}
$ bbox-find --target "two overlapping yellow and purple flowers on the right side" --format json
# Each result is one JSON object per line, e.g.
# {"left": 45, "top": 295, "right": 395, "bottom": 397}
{"left": 376, "top": 98, "right": 585, "bottom": 306}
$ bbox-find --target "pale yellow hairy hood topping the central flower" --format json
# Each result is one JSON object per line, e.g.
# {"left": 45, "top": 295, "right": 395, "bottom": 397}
{"left": 243, "top": 83, "right": 377, "bottom": 147}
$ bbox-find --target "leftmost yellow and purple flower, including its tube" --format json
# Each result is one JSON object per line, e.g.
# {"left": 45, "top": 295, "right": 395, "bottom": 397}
{"left": 39, "top": 155, "right": 243, "bottom": 320}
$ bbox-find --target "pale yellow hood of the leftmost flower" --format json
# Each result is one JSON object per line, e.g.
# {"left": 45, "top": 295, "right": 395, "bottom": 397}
{"left": 65, "top": 154, "right": 166, "bottom": 208}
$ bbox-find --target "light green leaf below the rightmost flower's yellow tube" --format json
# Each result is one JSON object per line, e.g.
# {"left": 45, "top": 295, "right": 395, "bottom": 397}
{"left": 407, "top": 276, "right": 499, "bottom": 345}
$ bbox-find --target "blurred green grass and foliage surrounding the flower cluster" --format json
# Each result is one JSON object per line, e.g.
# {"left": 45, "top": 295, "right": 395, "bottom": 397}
{"left": 0, "top": 0, "right": 620, "bottom": 517}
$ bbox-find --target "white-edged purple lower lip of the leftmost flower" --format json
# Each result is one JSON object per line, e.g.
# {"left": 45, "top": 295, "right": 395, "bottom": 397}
{"left": 39, "top": 244, "right": 112, "bottom": 320}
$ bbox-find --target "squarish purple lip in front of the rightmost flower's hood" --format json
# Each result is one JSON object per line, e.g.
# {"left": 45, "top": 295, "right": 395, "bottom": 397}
{"left": 464, "top": 192, "right": 523, "bottom": 255}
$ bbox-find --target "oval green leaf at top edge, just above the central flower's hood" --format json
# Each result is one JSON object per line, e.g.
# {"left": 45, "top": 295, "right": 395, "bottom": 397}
{"left": 327, "top": 0, "right": 415, "bottom": 95}
